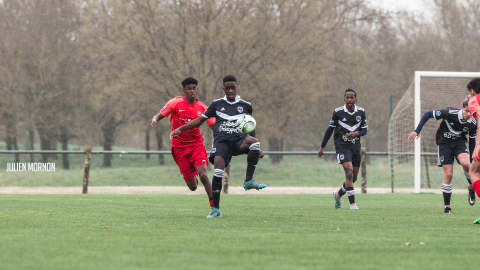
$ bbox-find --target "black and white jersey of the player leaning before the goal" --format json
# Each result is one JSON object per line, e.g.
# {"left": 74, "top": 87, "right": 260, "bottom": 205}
{"left": 433, "top": 107, "right": 477, "bottom": 144}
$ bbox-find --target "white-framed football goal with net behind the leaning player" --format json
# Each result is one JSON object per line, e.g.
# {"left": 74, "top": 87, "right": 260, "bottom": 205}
{"left": 388, "top": 71, "right": 480, "bottom": 193}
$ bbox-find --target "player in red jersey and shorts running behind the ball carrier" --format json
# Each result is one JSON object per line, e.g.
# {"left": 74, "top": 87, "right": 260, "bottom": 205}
{"left": 151, "top": 77, "right": 215, "bottom": 212}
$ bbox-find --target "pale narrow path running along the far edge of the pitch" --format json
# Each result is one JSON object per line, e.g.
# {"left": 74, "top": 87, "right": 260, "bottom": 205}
{"left": 0, "top": 186, "right": 467, "bottom": 195}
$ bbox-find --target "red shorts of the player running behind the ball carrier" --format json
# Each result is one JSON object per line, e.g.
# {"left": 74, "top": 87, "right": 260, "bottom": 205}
{"left": 172, "top": 144, "right": 208, "bottom": 181}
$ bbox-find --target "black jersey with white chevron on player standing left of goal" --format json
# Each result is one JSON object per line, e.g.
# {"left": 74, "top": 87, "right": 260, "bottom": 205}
{"left": 330, "top": 105, "right": 367, "bottom": 148}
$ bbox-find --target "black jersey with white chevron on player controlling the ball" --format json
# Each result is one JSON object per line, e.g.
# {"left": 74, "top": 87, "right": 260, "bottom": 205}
{"left": 202, "top": 96, "right": 253, "bottom": 142}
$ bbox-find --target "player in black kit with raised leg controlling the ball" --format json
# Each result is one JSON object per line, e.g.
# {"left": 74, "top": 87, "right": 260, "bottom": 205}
{"left": 170, "top": 75, "right": 266, "bottom": 218}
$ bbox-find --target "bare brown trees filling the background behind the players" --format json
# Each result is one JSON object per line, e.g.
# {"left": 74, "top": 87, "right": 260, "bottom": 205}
{"left": 0, "top": 0, "right": 480, "bottom": 168}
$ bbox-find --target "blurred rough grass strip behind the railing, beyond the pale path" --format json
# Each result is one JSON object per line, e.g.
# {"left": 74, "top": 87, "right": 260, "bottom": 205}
{"left": 0, "top": 143, "right": 466, "bottom": 188}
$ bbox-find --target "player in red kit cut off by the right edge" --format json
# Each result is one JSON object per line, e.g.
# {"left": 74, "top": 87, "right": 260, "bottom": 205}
{"left": 467, "top": 78, "right": 480, "bottom": 224}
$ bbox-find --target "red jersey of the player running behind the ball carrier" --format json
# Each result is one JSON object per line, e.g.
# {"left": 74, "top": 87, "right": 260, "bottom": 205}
{"left": 160, "top": 97, "right": 215, "bottom": 147}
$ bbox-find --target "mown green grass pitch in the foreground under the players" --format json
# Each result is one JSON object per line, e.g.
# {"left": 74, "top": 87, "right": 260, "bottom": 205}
{"left": 0, "top": 194, "right": 480, "bottom": 270}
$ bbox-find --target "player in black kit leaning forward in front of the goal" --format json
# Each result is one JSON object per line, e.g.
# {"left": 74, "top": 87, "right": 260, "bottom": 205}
{"left": 408, "top": 98, "right": 477, "bottom": 214}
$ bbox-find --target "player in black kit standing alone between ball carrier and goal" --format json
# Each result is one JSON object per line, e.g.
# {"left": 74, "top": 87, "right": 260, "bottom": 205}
{"left": 318, "top": 89, "right": 367, "bottom": 210}
